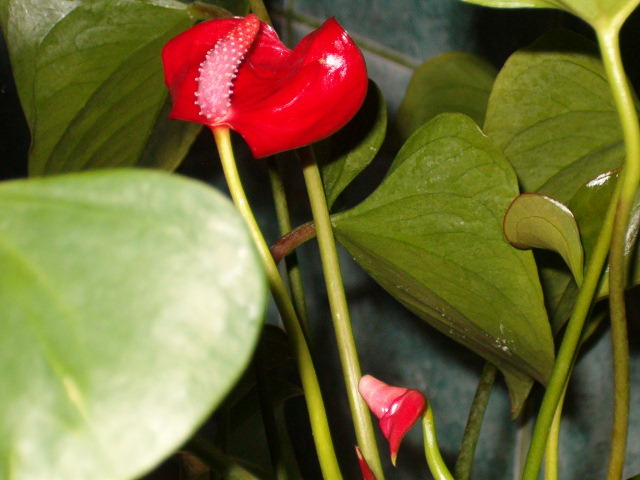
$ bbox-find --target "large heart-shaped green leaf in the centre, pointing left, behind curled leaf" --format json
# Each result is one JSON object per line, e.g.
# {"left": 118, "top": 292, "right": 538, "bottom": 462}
{"left": 335, "top": 114, "right": 554, "bottom": 410}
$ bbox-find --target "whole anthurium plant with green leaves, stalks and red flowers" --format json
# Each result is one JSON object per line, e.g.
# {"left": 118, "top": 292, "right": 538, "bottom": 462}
{"left": 0, "top": 0, "right": 640, "bottom": 480}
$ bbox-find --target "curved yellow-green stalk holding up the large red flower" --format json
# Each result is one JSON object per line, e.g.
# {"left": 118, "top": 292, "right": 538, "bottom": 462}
{"left": 213, "top": 127, "right": 342, "bottom": 480}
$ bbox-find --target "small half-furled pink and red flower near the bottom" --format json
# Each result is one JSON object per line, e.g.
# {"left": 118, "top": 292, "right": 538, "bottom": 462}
{"left": 358, "top": 375, "right": 427, "bottom": 465}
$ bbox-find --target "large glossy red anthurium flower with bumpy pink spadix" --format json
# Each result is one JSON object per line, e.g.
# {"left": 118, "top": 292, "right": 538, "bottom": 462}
{"left": 162, "top": 14, "right": 368, "bottom": 158}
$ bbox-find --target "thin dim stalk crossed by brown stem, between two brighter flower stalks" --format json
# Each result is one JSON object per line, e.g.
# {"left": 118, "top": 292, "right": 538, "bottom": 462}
{"left": 268, "top": 158, "right": 310, "bottom": 338}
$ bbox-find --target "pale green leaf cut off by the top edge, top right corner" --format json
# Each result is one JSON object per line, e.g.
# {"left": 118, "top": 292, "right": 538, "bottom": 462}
{"left": 463, "top": 0, "right": 640, "bottom": 28}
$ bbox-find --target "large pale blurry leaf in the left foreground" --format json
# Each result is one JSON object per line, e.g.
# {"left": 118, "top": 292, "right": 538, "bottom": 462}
{"left": 0, "top": 171, "right": 266, "bottom": 480}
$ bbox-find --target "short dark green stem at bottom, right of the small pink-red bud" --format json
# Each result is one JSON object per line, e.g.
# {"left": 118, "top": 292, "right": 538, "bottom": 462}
{"left": 454, "top": 362, "right": 497, "bottom": 480}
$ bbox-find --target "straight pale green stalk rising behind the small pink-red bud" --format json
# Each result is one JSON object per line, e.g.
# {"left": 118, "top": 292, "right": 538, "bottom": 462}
{"left": 299, "top": 147, "right": 384, "bottom": 480}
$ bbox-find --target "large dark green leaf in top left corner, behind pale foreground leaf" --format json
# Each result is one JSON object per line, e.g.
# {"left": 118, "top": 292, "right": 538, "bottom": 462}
{"left": 0, "top": 0, "right": 212, "bottom": 175}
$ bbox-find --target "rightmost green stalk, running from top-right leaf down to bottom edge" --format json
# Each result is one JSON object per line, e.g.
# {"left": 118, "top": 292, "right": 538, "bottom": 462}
{"left": 598, "top": 26, "right": 640, "bottom": 480}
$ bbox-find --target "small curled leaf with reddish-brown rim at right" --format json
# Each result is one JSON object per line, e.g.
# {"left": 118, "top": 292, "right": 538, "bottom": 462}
{"left": 502, "top": 193, "right": 584, "bottom": 285}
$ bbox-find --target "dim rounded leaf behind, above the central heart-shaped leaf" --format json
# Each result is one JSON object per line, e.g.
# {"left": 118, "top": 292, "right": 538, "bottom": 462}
{"left": 396, "top": 52, "right": 498, "bottom": 140}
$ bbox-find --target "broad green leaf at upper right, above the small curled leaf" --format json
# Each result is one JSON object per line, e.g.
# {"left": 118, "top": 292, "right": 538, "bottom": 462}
{"left": 484, "top": 31, "right": 624, "bottom": 204}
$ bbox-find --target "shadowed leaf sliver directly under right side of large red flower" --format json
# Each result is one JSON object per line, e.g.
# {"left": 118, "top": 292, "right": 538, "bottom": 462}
{"left": 313, "top": 80, "right": 387, "bottom": 207}
